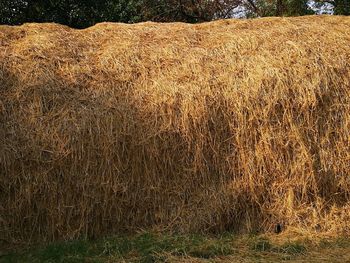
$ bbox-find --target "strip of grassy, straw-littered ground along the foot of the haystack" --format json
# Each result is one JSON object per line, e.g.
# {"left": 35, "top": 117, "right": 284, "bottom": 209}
{"left": 0, "top": 232, "right": 350, "bottom": 263}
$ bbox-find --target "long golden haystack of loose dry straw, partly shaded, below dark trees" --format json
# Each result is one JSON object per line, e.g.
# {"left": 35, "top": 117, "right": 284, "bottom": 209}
{"left": 0, "top": 16, "right": 350, "bottom": 242}
